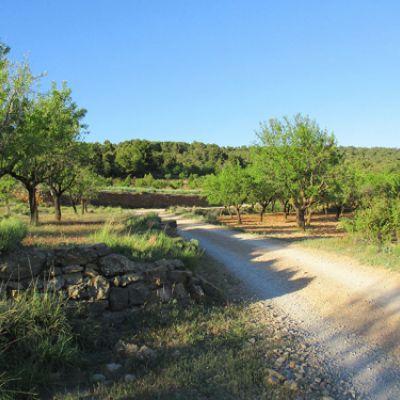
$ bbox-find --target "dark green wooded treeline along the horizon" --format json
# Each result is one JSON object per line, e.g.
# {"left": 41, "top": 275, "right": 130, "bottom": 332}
{"left": 83, "top": 139, "right": 400, "bottom": 179}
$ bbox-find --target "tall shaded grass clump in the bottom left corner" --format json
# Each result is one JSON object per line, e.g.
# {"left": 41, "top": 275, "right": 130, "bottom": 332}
{"left": 0, "top": 290, "right": 77, "bottom": 399}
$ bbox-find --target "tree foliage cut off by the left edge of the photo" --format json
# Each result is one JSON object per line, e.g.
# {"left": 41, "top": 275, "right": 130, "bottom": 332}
{"left": 0, "top": 43, "right": 33, "bottom": 178}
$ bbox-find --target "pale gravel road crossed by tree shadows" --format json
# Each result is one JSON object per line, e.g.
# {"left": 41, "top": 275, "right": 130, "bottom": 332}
{"left": 164, "top": 216, "right": 400, "bottom": 399}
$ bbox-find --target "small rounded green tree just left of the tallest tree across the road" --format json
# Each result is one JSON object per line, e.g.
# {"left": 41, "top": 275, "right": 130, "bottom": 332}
{"left": 204, "top": 164, "right": 251, "bottom": 224}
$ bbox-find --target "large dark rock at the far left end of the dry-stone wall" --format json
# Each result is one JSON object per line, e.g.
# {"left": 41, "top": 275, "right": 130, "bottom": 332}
{"left": 0, "top": 249, "right": 47, "bottom": 281}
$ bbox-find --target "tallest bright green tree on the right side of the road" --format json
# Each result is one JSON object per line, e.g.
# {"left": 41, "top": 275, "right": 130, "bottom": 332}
{"left": 258, "top": 114, "right": 340, "bottom": 230}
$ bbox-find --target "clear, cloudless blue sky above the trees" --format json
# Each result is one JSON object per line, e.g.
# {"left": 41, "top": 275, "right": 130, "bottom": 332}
{"left": 0, "top": 0, "right": 400, "bottom": 147}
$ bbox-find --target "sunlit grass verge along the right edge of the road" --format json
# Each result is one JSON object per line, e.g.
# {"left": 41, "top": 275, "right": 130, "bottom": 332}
{"left": 299, "top": 237, "right": 400, "bottom": 271}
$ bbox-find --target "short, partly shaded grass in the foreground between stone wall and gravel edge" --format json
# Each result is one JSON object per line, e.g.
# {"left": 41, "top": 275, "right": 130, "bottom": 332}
{"left": 55, "top": 304, "right": 295, "bottom": 400}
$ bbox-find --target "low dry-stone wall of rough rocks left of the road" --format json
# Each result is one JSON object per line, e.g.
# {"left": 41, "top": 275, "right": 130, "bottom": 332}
{"left": 0, "top": 244, "right": 218, "bottom": 311}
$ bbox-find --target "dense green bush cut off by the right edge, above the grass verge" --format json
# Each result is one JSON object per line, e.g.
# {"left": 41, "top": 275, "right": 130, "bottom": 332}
{"left": 342, "top": 198, "right": 400, "bottom": 245}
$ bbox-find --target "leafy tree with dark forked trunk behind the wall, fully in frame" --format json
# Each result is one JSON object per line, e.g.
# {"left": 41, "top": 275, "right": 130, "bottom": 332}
{"left": 11, "top": 84, "right": 85, "bottom": 224}
